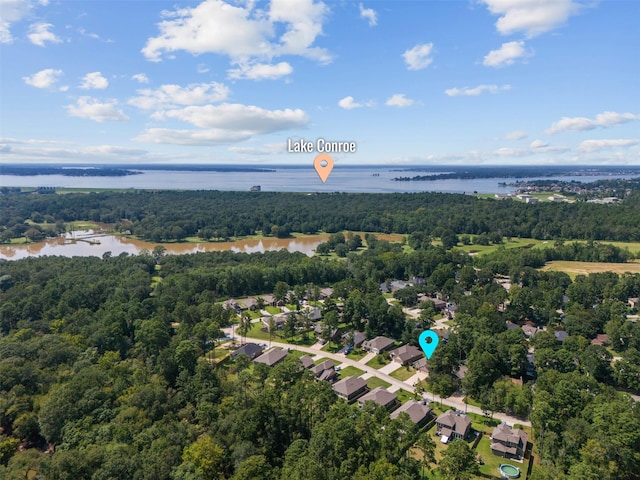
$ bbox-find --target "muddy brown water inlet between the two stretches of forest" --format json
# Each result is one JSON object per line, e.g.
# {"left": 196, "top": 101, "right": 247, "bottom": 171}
{"left": 0, "top": 230, "right": 402, "bottom": 260}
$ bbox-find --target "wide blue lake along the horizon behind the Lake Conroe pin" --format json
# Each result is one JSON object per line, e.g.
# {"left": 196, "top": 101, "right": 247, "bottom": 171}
{"left": 0, "top": 166, "right": 631, "bottom": 193}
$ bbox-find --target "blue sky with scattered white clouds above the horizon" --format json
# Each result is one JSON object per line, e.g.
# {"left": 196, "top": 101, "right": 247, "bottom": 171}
{"left": 0, "top": 0, "right": 640, "bottom": 166}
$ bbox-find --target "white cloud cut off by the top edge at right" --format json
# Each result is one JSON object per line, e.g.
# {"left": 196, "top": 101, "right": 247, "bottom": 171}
{"left": 480, "top": 0, "right": 582, "bottom": 38}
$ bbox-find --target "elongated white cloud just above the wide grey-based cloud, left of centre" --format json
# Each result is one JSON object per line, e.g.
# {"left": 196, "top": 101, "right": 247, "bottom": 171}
{"left": 128, "top": 82, "right": 229, "bottom": 110}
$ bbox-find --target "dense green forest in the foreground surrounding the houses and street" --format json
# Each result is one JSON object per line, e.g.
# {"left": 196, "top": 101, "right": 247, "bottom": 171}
{"left": 0, "top": 232, "right": 640, "bottom": 480}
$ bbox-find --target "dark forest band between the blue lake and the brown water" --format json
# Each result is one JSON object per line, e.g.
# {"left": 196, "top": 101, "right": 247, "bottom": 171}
{"left": 0, "top": 191, "right": 640, "bottom": 242}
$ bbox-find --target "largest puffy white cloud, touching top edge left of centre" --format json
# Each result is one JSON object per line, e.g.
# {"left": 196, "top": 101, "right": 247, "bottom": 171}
{"left": 142, "top": 0, "right": 331, "bottom": 64}
